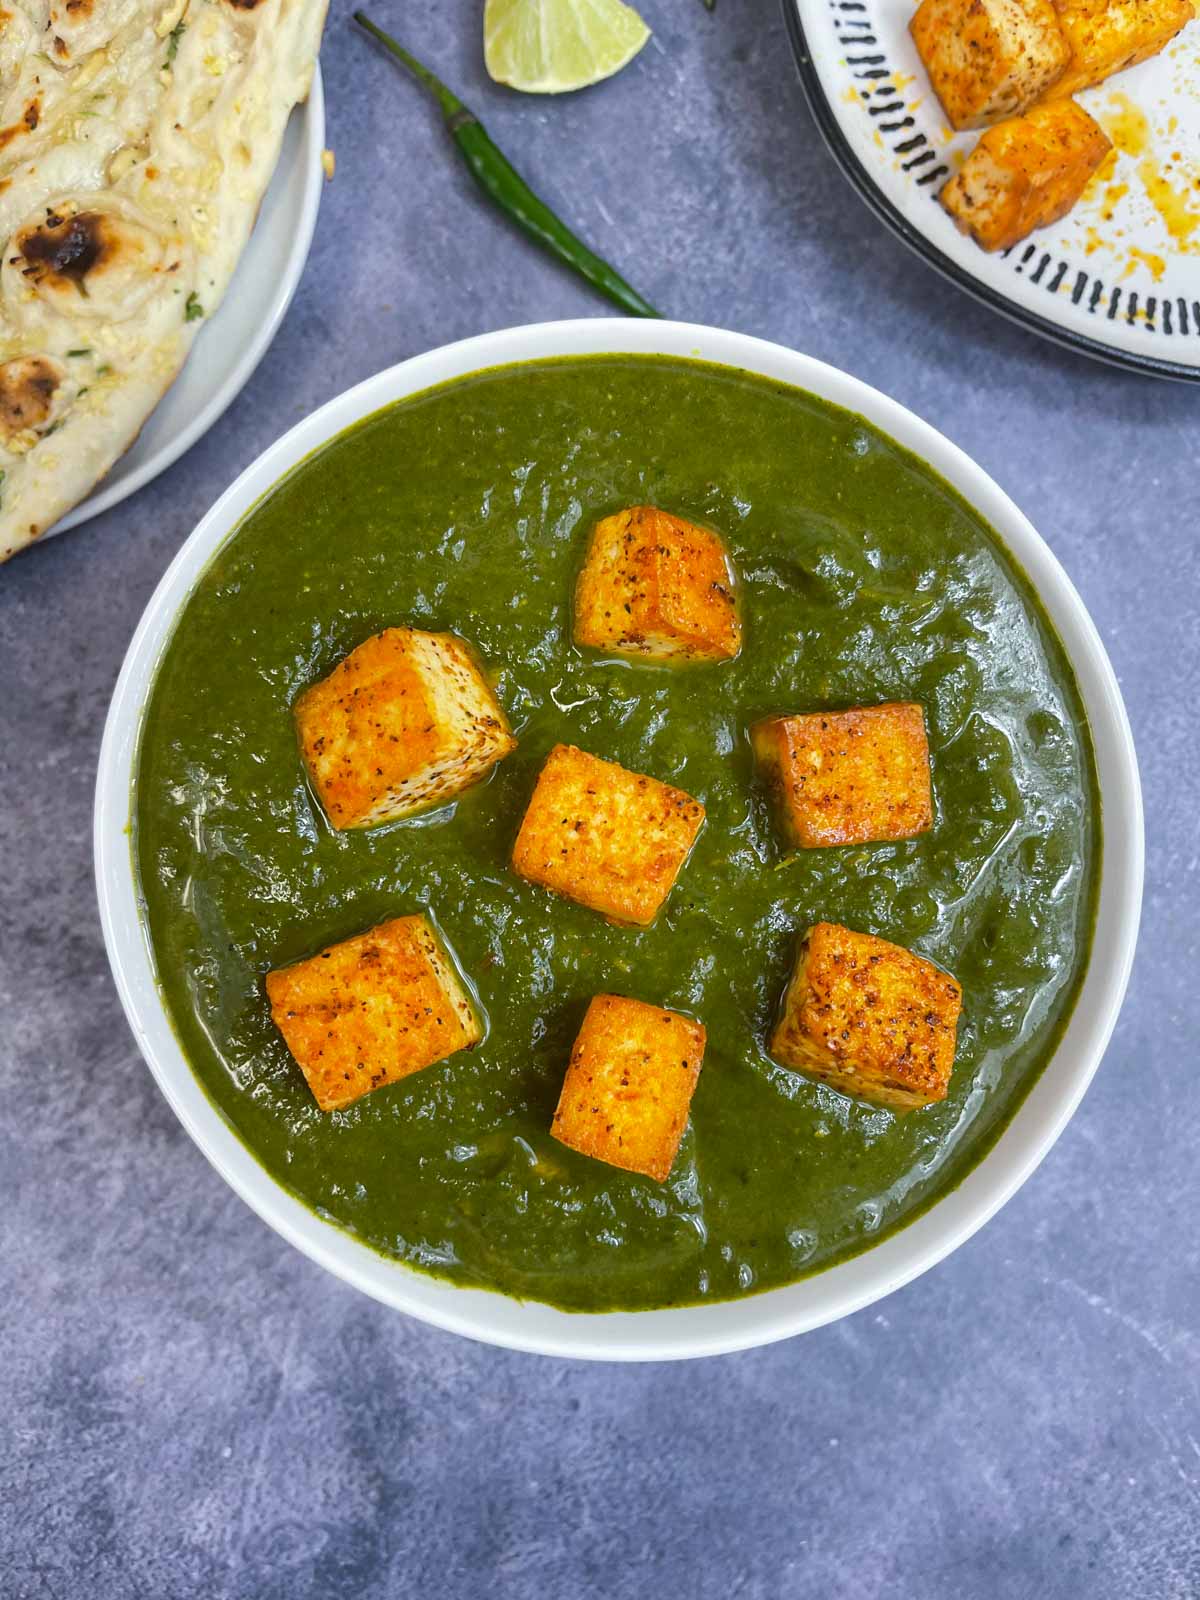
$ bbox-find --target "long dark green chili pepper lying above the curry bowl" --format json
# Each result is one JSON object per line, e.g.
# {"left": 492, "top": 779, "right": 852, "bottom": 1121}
{"left": 354, "top": 11, "right": 659, "bottom": 317}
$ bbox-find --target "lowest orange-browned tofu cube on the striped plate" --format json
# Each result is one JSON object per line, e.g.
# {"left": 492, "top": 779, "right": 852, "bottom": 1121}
{"left": 941, "top": 101, "right": 1110, "bottom": 250}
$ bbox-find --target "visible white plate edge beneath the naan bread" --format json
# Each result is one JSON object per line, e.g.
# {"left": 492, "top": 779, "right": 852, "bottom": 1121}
{"left": 52, "top": 67, "right": 325, "bottom": 539}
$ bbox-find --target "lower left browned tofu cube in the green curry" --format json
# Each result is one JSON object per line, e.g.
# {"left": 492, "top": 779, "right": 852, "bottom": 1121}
{"left": 266, "top": 917, "right": 483, "bottom": 1110}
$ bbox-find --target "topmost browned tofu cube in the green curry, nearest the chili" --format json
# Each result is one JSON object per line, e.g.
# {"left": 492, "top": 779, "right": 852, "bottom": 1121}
{"left": 574, "top": 506, "right": 742, "bottom": 662}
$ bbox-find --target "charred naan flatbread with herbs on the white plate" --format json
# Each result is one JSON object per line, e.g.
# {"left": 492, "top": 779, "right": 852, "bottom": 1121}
{"left": 0, "top": 0, "right": 326, "bottom": 560}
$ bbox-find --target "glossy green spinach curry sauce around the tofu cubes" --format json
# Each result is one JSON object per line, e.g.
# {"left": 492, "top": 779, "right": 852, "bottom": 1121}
{"left": 134, "top": 357, "right": 1099, "bottom": 1310}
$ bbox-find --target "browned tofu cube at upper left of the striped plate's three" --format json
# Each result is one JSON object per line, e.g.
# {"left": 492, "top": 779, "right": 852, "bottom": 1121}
{"left": 909, "top": 0, "right": 1069, "bottom": 128}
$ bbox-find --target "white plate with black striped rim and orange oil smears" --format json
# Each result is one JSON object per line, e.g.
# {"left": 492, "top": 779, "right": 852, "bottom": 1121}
{"left": 782, "top": 0, "right": 1200, "bottom": 382}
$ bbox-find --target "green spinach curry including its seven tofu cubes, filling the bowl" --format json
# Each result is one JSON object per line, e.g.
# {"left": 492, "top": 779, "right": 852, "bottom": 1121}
{"left": 134, "top": 357, "right": 1099, "bottom": 1310}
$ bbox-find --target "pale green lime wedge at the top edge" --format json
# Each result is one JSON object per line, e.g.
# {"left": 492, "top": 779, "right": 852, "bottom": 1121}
{"left": 483, "top": 0, "right": 650, "bottom": 94}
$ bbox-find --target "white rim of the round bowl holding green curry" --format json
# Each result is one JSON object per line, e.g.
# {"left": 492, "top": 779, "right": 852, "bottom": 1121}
{"left": 94, "top": 318, "right": 1142, "bottom": 1360}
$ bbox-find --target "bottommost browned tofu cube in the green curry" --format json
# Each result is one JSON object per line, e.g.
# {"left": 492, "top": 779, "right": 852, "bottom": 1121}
{"left": 550, "top": 995, "right": 706, "bottom": 1182}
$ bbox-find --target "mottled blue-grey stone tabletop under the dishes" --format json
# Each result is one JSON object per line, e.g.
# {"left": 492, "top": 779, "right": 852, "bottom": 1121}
{"left": 0, "top": 0, "right": 1200, "bottom": 1600}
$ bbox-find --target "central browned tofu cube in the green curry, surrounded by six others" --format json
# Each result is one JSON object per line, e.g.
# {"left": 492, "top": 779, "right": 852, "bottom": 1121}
{"left": 512, "top": 744, "right": 704, "bottom": 926}
